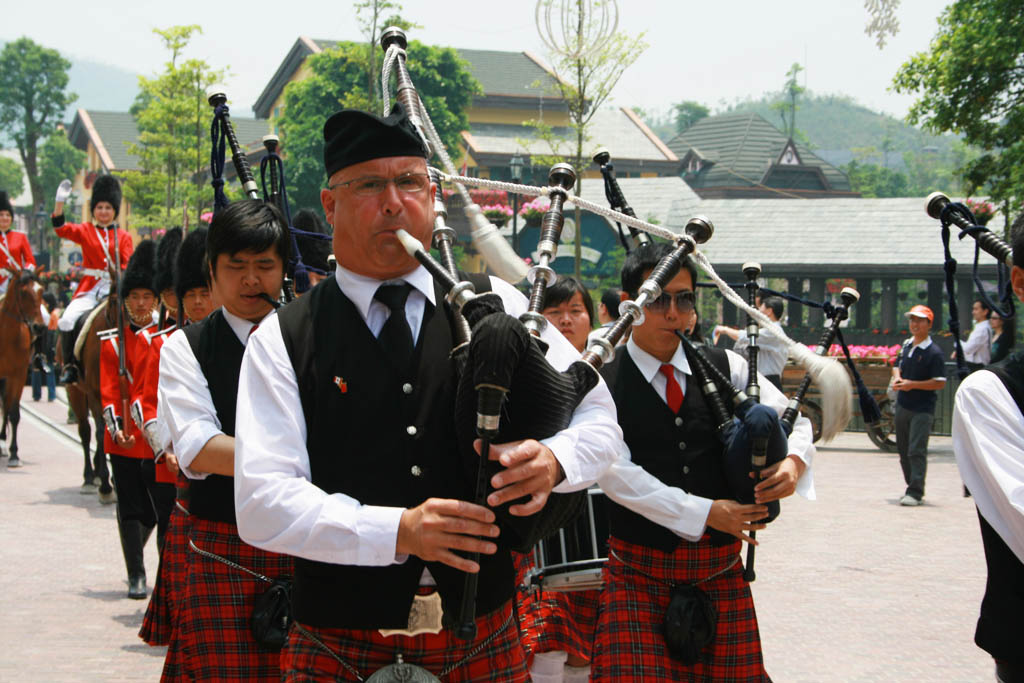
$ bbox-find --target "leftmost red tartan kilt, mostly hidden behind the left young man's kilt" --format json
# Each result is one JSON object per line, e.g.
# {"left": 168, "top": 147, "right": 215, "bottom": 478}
{"left": 138, "top": 501, "right": 188, "bottom": 645}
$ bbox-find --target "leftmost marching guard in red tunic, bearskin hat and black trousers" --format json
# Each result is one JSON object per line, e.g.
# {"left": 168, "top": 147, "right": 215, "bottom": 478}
{"left": 99, "top": 240, "right": 174, "bottom": 600}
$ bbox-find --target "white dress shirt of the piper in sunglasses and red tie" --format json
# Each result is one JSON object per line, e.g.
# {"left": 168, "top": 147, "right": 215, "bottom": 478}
{"left": 598, "top": 338, "right": 815, "bottom": 542}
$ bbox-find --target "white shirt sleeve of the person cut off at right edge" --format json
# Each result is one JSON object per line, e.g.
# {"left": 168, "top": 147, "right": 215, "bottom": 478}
{"left": 952, "top": 370, "right": 1024, "bottom": 562}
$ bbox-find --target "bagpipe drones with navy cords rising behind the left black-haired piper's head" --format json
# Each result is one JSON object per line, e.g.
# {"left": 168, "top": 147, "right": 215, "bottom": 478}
{"left": 201, "top": 89, "right": 331, "bottom": 308}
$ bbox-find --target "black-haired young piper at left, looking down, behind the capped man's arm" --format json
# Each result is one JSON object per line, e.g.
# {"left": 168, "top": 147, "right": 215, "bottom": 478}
{"left": 159, "top": 200, "right": 292, "bottom": 681}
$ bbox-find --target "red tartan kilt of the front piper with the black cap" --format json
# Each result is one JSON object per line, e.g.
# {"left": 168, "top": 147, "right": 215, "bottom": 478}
{"left": 281, "top": 601, "right": 528, "bottom": 683}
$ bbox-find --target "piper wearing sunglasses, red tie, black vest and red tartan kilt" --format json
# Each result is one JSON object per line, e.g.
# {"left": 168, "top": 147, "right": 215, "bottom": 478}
{"left": 592, "top": 244, "right": 814, "bottom": 682}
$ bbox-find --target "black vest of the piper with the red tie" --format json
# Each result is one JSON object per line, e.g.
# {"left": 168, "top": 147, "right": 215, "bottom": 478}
{"left": 601, "top": 347, "right": 735, "bottom": 553}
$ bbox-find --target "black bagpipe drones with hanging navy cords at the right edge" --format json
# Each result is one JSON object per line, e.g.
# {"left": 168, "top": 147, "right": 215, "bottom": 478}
{"left": 925, "top": 193, "right": 1014, "bottom": 379}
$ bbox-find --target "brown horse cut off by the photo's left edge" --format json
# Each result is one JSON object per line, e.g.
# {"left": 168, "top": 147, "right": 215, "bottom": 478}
{"left": 0, "top": 268, "right": 46, "bottom": 467}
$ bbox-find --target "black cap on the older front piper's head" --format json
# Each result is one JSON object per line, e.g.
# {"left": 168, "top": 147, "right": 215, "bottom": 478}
{"left": 324, "top": 103, "right": 427, "bottom": 178}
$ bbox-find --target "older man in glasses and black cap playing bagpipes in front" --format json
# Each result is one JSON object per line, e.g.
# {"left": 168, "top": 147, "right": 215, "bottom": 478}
{"left": 234, "top": 105, "right": 622, "bottom": 682}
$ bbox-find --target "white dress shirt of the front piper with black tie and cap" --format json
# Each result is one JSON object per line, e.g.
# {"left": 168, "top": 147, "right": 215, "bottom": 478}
{"left": 234, "top": 266, "right": 625, "bottom": 565}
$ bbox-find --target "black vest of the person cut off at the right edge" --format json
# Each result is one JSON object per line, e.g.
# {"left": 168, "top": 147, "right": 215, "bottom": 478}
{"left": 974, "top": 353, "right": 1024, "bottom": 663}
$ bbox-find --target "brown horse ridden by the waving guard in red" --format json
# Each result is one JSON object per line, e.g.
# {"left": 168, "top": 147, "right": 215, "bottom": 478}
{"left": 56, "top": 293, "right": 118, "bottom": 505}
